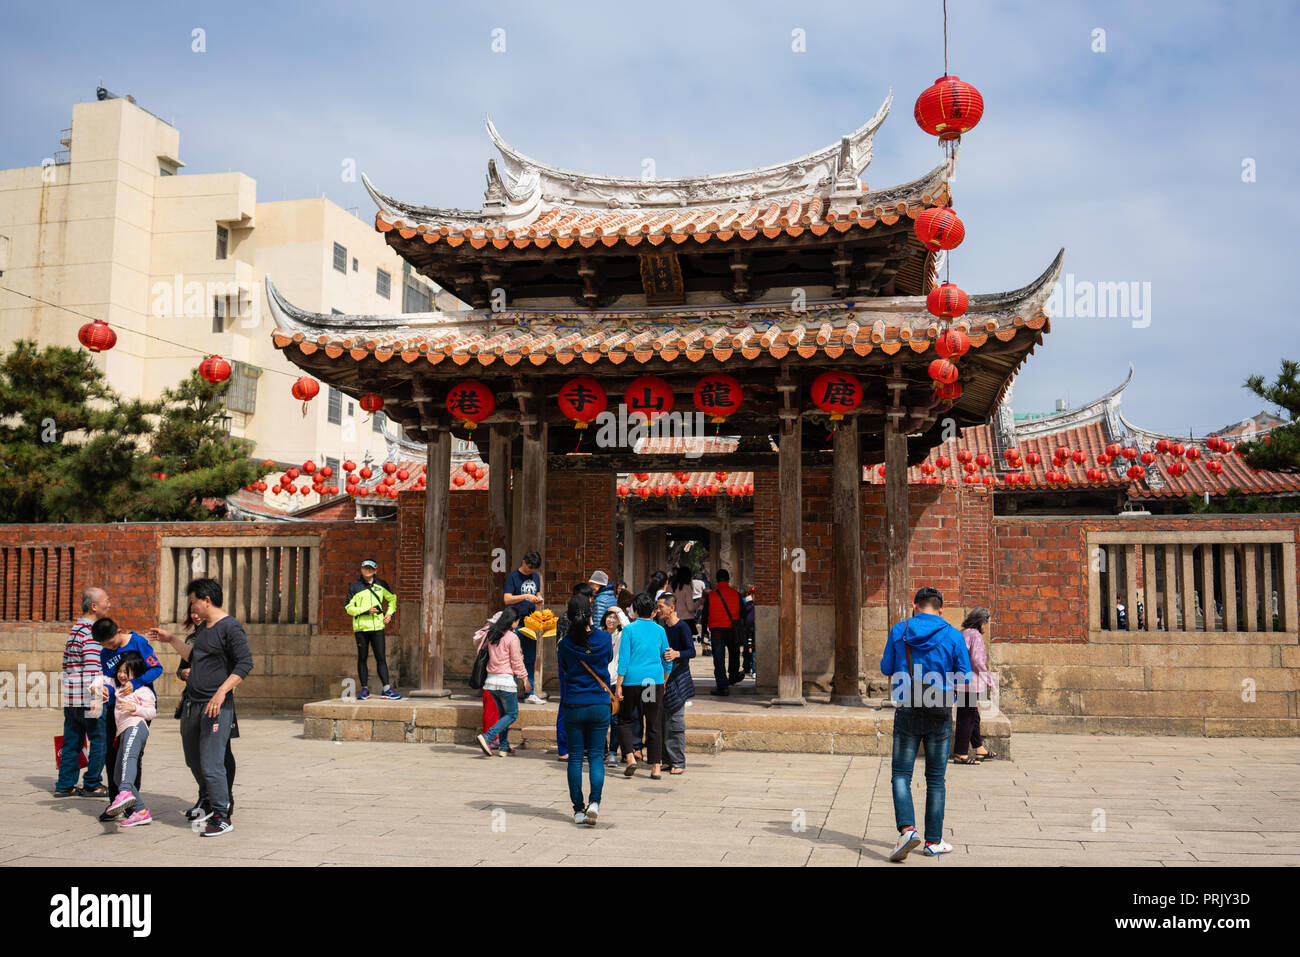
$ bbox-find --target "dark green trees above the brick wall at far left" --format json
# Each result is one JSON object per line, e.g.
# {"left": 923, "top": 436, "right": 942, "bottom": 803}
{"left": 0, "top": 341, "right": 263, "bottom": 523}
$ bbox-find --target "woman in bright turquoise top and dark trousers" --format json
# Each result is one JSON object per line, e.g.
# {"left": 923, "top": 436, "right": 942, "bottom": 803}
{"left": 615, "top": 592, "right": 672, "bottom": 780}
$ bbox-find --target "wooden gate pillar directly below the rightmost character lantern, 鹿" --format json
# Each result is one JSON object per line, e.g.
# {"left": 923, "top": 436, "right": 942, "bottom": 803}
{"left": 831, "top": 417, "right": 863, "bottom": 705}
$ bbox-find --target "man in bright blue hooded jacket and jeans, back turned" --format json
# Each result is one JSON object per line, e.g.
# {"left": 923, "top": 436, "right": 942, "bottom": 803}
{"left": 880, "top": 588, "right": 972, "bottom": 861}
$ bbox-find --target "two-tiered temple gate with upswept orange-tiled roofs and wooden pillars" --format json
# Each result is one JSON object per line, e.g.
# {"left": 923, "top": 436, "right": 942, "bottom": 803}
{"left": 267, "top": 93, "right": 1063, "bottom": 705}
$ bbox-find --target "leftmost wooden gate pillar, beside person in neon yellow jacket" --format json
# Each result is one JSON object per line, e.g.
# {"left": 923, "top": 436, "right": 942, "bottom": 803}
{"left": 411, "top": 429, "right": 451, "bottom": 698}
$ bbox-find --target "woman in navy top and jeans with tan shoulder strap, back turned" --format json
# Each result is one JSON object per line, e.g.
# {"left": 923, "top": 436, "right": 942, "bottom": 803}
{"left": 555, "top": 594, "right": 614, "bottom": 827}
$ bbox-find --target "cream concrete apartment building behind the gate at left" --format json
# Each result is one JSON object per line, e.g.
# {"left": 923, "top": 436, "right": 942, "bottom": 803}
{"left": 0, "top": 91, "right": 463, "bottom": 486}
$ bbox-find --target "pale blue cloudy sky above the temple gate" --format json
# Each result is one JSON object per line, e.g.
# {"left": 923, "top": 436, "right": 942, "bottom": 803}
{"left": 0, "top": 0, "right": 1300, "bottom": 433}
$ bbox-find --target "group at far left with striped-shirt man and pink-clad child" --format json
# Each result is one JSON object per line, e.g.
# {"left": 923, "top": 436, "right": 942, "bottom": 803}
{"left": 55, "top": 579, "right": 254, "bottom": 837}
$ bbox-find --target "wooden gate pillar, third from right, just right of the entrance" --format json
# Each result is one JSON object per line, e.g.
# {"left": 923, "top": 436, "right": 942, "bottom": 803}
{"left": 772, "top": 395, "right": 806, "bottom": 705}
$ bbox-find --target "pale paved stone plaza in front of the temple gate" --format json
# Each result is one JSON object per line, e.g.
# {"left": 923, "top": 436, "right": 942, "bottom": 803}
{"left": 0, "top": 710, "right": 1300, "bottom": 867}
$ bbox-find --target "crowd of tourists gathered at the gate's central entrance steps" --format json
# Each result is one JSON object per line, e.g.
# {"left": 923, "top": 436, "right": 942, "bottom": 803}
{"left": 471, "top": 551, "right": 754, "bottom": 826}
